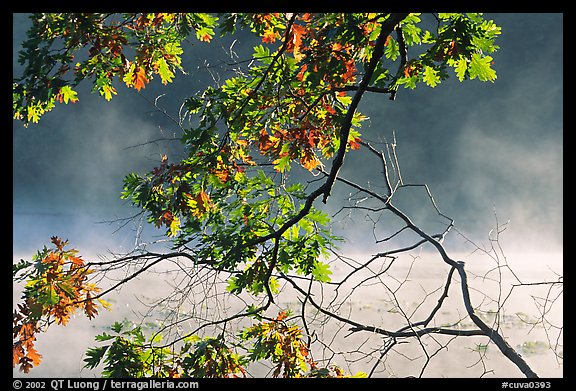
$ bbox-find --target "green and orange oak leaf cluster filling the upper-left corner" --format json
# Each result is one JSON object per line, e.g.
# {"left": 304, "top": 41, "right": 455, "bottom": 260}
{"left": 13, "top": 13, "right": 215, "bottom": 126}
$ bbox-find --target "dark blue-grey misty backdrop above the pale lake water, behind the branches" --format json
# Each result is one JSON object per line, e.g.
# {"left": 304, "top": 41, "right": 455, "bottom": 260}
{"left": 13, "top": 14, "right": 563, "bottom": 251}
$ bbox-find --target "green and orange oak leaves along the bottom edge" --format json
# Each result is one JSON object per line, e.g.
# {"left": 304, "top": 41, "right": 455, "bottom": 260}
{"left": 84, "top": 311, "right": 366, "bottom": 378}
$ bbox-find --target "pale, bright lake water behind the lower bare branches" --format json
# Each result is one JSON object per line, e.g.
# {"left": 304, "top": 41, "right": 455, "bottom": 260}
{"left": 13, "top": 248, "right": 563, "bottom": 378}
